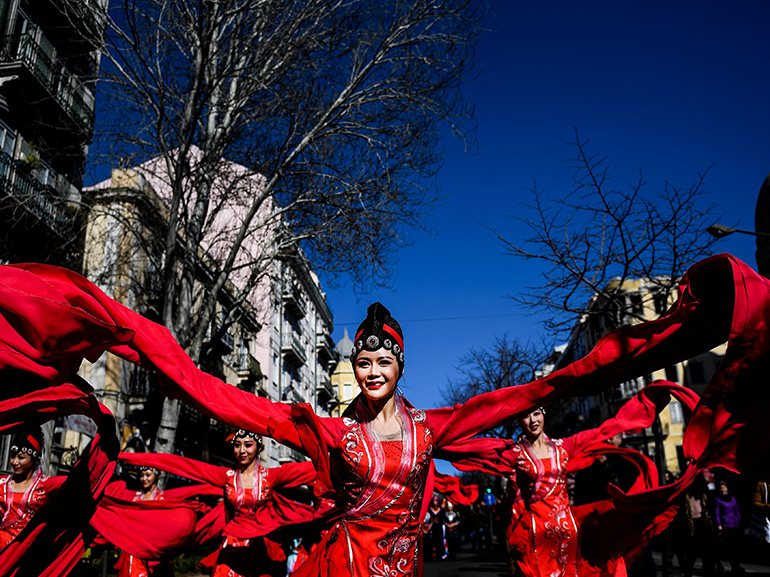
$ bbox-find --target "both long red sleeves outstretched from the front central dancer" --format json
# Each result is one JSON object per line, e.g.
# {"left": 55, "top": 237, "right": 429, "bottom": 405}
{"left": 0, "top": 255, "right": 770, "bottom": 576}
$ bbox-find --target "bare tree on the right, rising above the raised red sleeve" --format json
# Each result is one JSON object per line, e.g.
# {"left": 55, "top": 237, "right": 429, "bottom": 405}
{"left": 498, "top": 131, "right": 717, "bottom": 335}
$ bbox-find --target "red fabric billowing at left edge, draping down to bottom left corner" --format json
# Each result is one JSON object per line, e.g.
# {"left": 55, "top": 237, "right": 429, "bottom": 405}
{"left": 0, "top": 267, "right": 133, "bottom": 576}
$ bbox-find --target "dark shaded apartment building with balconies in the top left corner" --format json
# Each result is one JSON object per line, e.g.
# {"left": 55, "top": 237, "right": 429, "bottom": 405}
{"left": 0, "top": 0, "right": 107, "bottom": 270}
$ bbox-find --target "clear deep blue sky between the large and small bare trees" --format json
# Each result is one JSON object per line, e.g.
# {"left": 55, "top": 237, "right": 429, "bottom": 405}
{"left": 328, "top": 0, "right": 770, "bottom": 418}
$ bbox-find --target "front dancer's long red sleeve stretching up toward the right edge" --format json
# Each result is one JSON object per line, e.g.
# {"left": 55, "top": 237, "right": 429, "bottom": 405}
{"left": 426, "top": 255, "right": 736, "bottom": 452}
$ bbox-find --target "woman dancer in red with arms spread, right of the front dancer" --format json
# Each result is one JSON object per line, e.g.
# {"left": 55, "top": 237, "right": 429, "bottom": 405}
{"left": 438, "top": 381, "right": 698, "bottom": 577}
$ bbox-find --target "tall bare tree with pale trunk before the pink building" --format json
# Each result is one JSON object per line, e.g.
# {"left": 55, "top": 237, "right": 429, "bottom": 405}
{"left": 88, "top": 0, "right": 480, "bottom": 451}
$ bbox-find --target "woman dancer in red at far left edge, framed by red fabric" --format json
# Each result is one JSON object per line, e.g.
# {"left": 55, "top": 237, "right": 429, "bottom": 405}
{"left": 0, "top": 429, "right": 48, "bottom": 549}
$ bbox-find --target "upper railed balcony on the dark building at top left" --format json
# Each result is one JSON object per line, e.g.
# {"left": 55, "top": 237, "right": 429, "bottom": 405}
{"left": 0, "top": 33, "right": 94, "bottom": 136}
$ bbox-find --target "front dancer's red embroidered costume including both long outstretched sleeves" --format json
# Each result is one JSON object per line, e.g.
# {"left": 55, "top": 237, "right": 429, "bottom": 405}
{"left": 0, "top": 255, "right": 770, "bottom": 575}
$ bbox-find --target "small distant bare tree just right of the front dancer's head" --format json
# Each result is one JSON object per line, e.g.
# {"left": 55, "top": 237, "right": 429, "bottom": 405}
{"left": 441, "top": 335, "right": 544, "bottom": 439}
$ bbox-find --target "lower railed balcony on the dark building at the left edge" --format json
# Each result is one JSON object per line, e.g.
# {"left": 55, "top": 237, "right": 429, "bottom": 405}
{"left": 0, "top": 152, "right": 72, "bottom": 231}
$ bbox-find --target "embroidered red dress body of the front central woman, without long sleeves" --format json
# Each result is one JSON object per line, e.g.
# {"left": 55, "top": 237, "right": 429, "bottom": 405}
{"left": 276, "top": 395, "right": 516, "bottom": 577}
